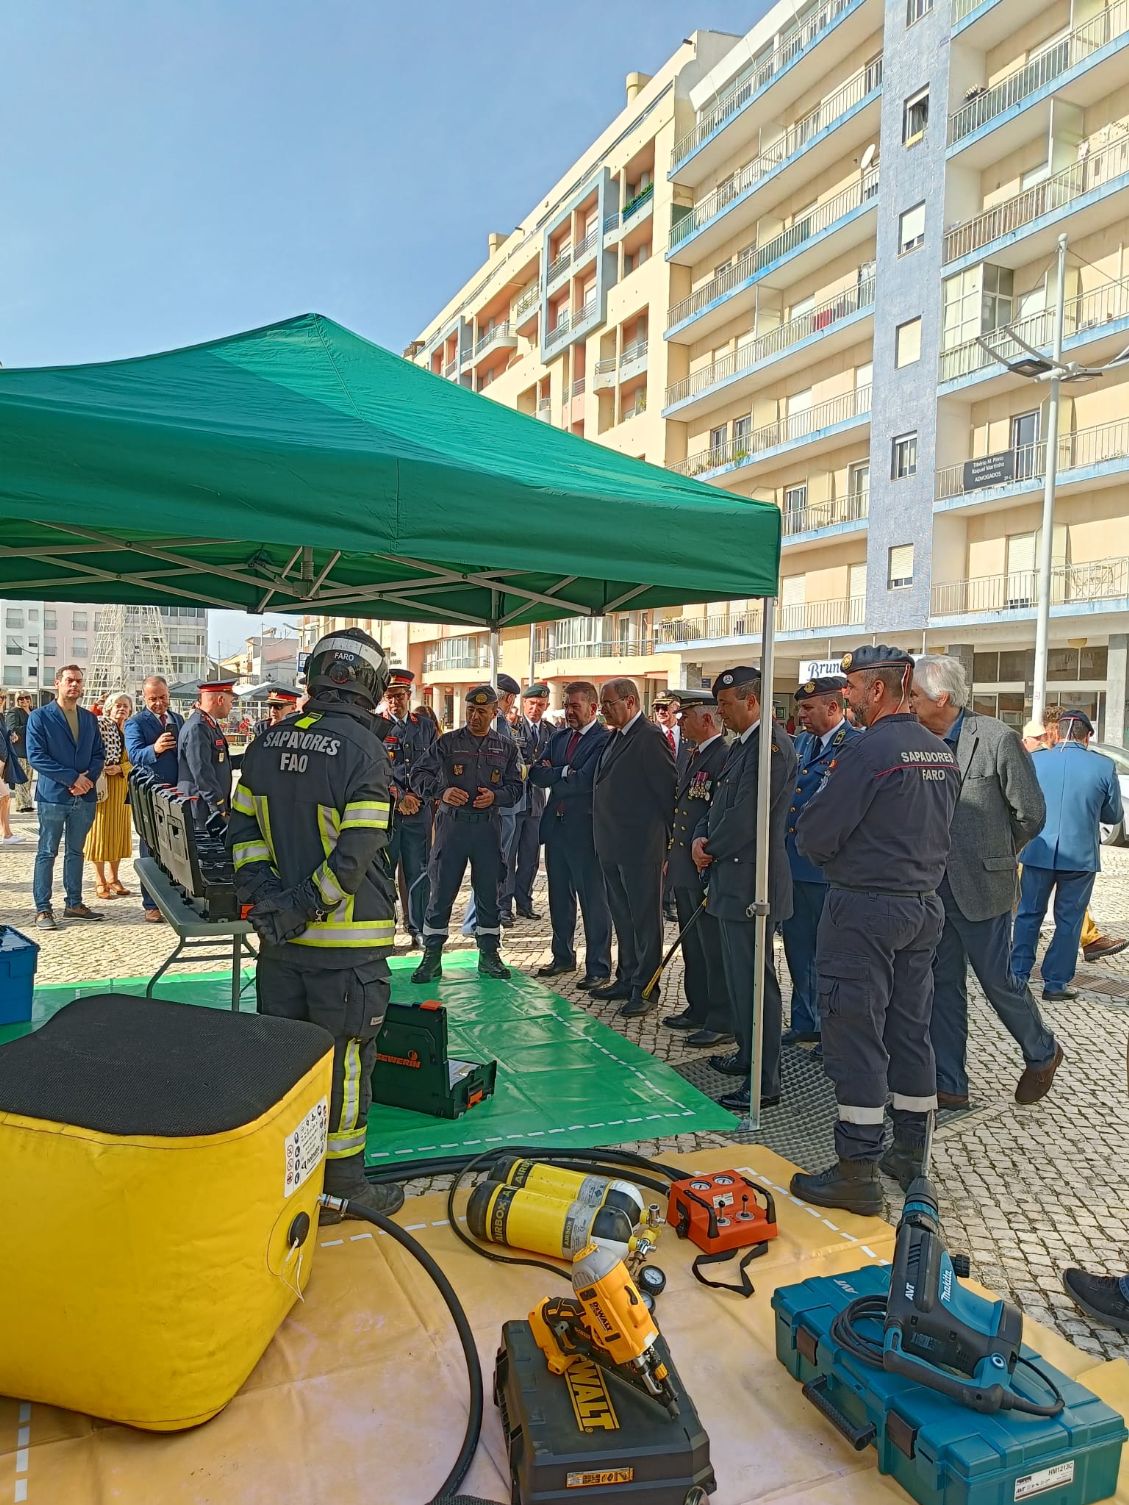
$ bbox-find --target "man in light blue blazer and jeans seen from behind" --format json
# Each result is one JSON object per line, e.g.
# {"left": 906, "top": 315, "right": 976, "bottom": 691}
{"left": 1012, "top": 710, "right": 1123, "bottom": 1004}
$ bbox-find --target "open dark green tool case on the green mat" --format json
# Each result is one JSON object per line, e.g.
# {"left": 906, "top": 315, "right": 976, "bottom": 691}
{"left": 372, "top": 998, "right": 498, "bottom": 1118}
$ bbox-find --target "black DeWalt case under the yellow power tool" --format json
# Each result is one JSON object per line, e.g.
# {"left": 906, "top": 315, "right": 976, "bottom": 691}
{"left": 494, "top": 1321, "right": 717, "bottom": 1505}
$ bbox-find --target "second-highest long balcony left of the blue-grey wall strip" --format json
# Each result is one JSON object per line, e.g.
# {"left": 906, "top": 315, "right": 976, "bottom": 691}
{"left": 667, "top": 57, "right": 882, "bottom": 265}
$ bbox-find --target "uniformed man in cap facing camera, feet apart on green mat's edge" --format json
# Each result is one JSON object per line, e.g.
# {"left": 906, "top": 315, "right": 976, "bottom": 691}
{"left": 411, "top": 685, "right": 521, "bottom": 983}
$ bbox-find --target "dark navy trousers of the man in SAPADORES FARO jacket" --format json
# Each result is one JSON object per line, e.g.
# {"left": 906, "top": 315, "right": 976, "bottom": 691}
{"left": 816, "top": 886, "right": 945, "bottom": 1160}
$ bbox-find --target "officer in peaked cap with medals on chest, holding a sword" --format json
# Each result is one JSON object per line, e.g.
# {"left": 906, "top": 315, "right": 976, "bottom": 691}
{"left": 662, "top": 689, "right": 733, "bottom": 1049}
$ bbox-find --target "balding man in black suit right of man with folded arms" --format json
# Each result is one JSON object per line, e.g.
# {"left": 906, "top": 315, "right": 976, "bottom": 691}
{"left": 592, "top": 679, "right": 674, "bottom": 1019}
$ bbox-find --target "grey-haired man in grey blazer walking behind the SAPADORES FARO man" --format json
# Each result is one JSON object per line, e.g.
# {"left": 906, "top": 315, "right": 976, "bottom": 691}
{"left": 909, "top": 655, "right": 1063, "bottom": 1108}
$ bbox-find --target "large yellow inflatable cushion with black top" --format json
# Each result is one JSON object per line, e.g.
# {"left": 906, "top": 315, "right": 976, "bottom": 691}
{"left": 0, "top": 993, "right": 333, "bottom": 1431}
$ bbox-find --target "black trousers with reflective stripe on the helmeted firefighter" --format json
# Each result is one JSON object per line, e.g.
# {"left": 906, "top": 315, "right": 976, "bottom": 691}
{"left": 254, "top": 945, "right": 388, "bottom": 1196}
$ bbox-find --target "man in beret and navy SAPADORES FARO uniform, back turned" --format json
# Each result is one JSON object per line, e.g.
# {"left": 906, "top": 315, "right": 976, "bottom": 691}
{"left": 792, "top": 643, "right": 960, "bottom": 1213}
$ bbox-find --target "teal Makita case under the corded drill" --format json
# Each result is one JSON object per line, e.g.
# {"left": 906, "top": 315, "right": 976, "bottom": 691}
{"left": 772, "top": 1264, "right": 1129, "bottom": 1505}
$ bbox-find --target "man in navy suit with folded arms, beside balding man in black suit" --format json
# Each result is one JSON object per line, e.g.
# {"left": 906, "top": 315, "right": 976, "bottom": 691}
{"left": 528, "top": 680, "right": 611, "bottom": 989}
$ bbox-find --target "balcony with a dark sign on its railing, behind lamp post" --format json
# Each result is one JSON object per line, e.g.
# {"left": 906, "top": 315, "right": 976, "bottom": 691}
{"left": 933, "top": 418, "right": 1129, "bottom": 512}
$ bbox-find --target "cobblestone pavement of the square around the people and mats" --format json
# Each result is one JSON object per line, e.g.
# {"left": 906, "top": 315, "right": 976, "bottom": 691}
{"left": 0, "top": 816, "right": 1129, "bottom": 1358}
